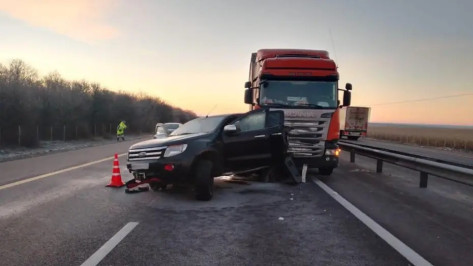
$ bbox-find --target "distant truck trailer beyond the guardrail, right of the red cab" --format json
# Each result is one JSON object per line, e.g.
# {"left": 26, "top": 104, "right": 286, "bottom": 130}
{"left": 340, "top": 106, "right": 370, "bottom": 140}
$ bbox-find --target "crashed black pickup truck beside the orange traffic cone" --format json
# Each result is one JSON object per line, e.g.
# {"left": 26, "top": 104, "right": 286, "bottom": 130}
{"left": 127, "top": 109, "right": 287, "bottom": 200}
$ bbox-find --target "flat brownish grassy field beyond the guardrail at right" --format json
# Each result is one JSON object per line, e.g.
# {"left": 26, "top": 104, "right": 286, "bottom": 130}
{"left": 368, "top": 124, "right": 473, "bottom": 152}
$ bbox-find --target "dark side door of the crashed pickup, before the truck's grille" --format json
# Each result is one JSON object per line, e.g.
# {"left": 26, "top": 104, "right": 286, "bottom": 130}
{"left": 223, "top": 109, "right": 285, "bottom": 171}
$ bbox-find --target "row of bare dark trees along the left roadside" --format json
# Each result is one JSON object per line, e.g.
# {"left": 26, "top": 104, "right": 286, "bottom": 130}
{"left": 0, "top": 59, "right": 196, "bottom": 146}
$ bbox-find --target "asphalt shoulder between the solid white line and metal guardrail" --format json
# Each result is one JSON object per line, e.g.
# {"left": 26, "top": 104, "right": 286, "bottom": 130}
{"left": 325, "top": 152, "right": 473, "bottom": 265}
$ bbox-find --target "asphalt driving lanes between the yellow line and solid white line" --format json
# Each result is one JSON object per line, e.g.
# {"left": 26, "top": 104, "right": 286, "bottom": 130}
{"left": 0, "top": 144, "right": 408, "bottom": 265}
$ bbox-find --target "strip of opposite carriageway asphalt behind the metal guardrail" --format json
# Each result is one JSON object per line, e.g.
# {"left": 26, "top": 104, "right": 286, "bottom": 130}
{"left": 343, "top": 138, "right": 473, "bottom": 167}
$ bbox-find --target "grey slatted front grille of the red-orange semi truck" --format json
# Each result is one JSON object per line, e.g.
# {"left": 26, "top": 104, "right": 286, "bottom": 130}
{"left": 284, "top": 118, "right": 330, "bottom": 158}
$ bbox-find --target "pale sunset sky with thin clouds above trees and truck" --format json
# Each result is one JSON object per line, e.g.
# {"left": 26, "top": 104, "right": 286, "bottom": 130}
{"left": 0, "top": 0, "right": 473, "bottom": 126}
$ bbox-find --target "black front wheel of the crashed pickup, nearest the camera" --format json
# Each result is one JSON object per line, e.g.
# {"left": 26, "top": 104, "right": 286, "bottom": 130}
{"left": 195, "top": 160, "right": 214, "bottom": 201}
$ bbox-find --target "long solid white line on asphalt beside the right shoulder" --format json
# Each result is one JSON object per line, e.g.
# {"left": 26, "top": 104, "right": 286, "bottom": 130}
{"left": 313, "top": 180, "right": 432, "bottom": 265}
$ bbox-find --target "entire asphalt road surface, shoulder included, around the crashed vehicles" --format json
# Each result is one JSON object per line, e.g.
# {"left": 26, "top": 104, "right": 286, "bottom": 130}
{"left": 0, "top": 142, "right": 473, "bottom": 265}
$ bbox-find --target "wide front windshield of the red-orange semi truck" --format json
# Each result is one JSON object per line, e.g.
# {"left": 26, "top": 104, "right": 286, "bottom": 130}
{"left": 260, "top": 80, "right": 337, "bottom": 109}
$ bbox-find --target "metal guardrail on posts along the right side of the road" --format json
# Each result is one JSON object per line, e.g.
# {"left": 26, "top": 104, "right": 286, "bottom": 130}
{"left": 338, "top": 141, "right": 473, "bottom": 188}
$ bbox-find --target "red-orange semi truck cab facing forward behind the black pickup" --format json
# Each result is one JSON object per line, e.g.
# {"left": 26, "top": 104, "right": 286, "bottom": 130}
{"left": 245, "top": 49, "right": 351, "bottom": 175}
